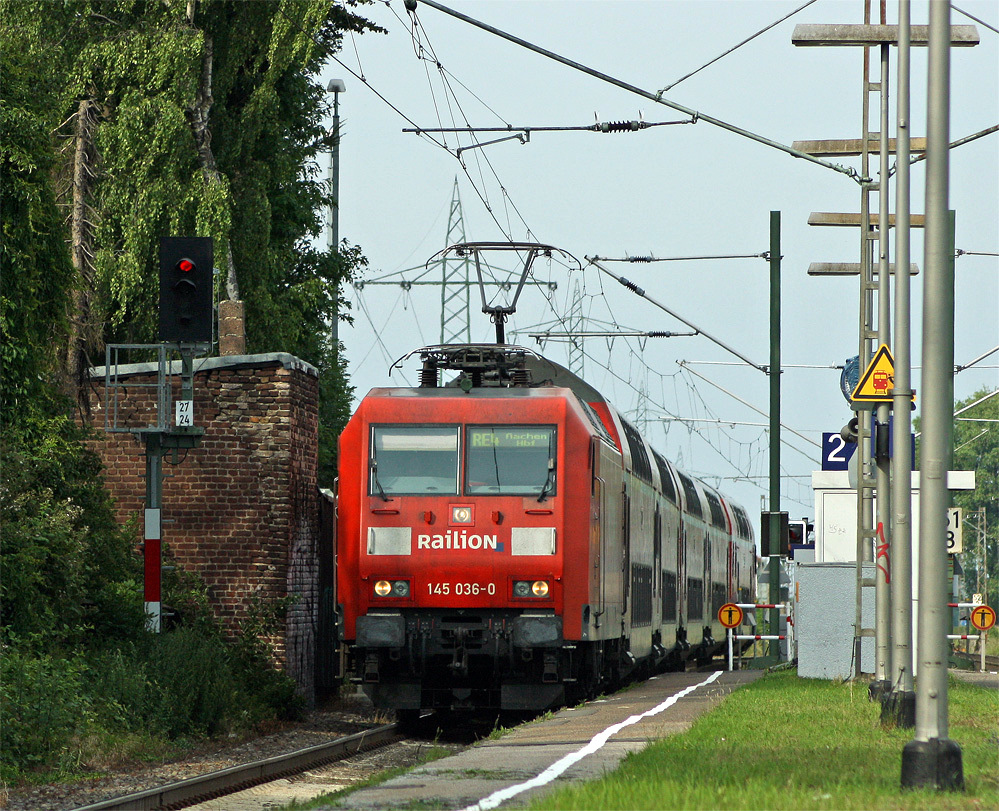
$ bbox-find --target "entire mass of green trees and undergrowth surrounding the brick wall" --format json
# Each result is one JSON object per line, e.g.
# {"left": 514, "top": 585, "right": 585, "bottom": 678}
{"left": 0, "top": 0, "right": 375, "bottom": 788}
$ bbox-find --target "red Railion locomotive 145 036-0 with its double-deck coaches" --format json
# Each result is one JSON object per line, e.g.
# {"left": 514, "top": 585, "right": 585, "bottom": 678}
{"left": 337, "top": 345, "right": 756, "bottom": 716}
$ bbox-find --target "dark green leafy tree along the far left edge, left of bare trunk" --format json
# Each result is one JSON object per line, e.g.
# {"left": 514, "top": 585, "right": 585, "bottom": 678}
{"left": 0, "top": 17, "right": 142, "bottom": 643}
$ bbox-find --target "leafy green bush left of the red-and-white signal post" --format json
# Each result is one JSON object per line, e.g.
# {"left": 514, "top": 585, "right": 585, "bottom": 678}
{"left": 0, "top": 414, "right": 143, "bottom": 643}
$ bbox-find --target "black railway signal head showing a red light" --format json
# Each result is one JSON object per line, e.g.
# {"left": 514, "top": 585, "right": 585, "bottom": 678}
{"left": 159, "top": 237, "right": 214, "bottom": 343}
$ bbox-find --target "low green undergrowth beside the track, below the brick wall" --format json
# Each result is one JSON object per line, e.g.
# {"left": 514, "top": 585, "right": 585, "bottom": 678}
{"left": 0, "top": 595, "right": 303, "bottom": 780}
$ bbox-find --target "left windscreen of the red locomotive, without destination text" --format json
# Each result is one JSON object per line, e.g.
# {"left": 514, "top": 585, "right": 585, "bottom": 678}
{"left": 369, "top": 425, "right": 458, "bottom": 496}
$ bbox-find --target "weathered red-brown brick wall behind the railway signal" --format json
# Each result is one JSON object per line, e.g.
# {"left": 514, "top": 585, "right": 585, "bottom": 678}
{"left": 91, "top": 354, "right": 319, "bottom": 701}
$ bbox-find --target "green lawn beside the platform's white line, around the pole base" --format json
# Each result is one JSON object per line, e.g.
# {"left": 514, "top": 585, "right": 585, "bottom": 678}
{"left": 529, "top": 672, "right": 999, "bottom": 811}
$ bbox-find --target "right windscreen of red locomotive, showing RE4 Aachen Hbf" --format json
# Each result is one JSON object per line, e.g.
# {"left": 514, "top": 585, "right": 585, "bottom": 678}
{"left": 465, "top": 425, "right": 555, "bottom": 494}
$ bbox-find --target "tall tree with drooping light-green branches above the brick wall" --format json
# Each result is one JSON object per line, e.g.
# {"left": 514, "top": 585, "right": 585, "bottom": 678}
{"left": 0, "top": 0, "right": 377, "bottom": 476}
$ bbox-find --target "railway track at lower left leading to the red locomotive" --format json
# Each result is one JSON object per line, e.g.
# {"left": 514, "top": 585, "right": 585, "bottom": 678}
{"left": 76, "top": 724, "right": 405, "bottom": 811}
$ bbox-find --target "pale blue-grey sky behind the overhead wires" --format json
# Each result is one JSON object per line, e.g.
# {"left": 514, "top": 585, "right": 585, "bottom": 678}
{"left": 322, "top": 0, "right": 999, "bottom": 518}
